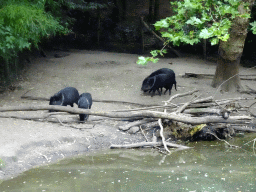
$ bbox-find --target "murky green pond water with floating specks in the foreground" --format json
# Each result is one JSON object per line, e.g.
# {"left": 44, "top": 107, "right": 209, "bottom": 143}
{"left": 0, "top": 134, "right": 256, "bottom": 192}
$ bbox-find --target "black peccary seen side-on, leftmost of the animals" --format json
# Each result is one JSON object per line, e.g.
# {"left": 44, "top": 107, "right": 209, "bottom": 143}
{"left": 49, "top": 87, "right": 79, "bottom": 112}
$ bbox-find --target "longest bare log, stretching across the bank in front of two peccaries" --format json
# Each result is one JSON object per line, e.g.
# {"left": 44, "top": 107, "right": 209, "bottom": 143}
{"left": 0, "top": 105, "right": 252, "bottom": 124}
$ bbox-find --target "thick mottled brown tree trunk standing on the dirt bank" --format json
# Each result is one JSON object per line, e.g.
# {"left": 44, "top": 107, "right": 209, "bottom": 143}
{"left": 212, "top": 0, "right": 254, "bottom": 91}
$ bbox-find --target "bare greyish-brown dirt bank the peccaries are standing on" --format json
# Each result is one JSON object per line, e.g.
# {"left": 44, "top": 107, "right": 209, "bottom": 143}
{"left": 0, "top": 50, "right": 256, "bottom": 179}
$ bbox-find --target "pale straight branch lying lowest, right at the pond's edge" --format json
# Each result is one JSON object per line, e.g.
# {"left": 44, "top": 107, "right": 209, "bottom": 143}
{"left": 110, "top": 142, "right": 191, "bottom": 149}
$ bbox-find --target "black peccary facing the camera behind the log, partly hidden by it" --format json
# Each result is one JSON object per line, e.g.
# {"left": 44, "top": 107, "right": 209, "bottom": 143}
{"left": 78, "top": 93, "right": 92, "bottom": 121}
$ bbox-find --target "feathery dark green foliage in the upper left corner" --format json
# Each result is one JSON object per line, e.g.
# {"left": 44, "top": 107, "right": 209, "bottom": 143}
{"left": 0, "top": 0, "right": 65, "bottom": 59}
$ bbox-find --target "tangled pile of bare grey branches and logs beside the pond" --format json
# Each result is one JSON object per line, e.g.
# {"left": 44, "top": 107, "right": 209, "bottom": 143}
{"left": 0, "top": 90, "right": 255, "bottom": 152}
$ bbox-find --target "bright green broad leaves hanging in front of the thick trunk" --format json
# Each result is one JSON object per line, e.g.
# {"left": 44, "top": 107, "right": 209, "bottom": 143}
{"left": 137, "top": 0, "right": 253, "bottom": 65}
